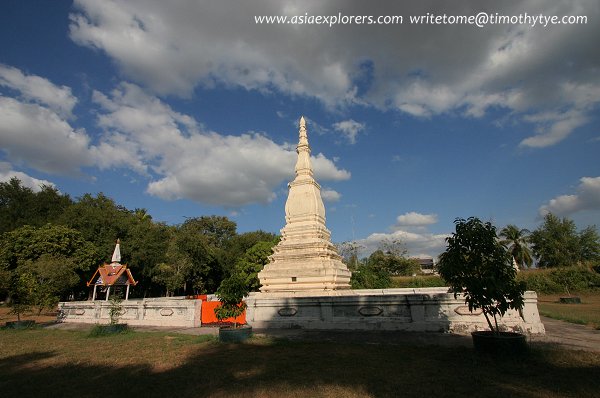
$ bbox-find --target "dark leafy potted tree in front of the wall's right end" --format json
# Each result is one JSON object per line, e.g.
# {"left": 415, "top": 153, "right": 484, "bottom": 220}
{"left": 438, "top": 217, "right": 525, "bottom": 333}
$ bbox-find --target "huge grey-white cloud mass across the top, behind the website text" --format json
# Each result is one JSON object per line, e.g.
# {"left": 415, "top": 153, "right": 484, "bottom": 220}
{"left": 70, "top": 0, "right": 600, "bottom": 148}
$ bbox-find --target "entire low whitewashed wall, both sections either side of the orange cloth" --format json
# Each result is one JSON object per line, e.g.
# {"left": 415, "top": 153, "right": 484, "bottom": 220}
{"left": 59, "top": 288, "right": 545, "bottom": 334}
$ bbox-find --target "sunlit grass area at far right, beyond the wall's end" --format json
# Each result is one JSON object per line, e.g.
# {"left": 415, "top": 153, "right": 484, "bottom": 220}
{"left": 538, "top": 292, "right": 600, "bottom": 329}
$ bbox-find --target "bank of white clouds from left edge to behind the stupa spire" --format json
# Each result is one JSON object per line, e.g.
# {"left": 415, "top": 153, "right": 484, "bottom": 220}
{"left": 0, "top": 62, "right": 350, "bottom": 207}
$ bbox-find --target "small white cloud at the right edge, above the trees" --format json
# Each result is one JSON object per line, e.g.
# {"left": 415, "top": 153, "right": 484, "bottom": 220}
{"left": 539, "top": 177, "right": 600, "bottom": 217}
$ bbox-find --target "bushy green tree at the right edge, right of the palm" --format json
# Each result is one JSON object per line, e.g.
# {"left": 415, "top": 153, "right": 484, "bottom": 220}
{"left": 531, "top": 213, "right": 600, "bottom": 267}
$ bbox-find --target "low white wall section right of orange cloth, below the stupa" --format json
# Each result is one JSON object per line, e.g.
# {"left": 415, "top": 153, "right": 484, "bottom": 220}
{"left": 246, "top": 288, "right": 545, "bottom": 334}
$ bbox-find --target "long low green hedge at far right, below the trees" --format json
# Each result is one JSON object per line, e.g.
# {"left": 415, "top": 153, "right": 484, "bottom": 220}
{"left": 518, "top": 266, "right": 600, "bottom": 294}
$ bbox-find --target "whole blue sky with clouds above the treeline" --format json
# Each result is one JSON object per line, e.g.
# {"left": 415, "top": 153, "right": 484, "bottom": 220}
{"left": 0, "top": 0, "right": 600, "bottom": 256}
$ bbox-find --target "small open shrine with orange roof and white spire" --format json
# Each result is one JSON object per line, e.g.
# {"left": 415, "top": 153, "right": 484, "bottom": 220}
{"left": 87, "top": 239, "right": 137, "bottom": 301}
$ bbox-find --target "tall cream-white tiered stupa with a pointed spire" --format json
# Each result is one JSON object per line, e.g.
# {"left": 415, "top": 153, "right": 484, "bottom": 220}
{"left": 258, "top": 117, "right": 351, "bottom": 293}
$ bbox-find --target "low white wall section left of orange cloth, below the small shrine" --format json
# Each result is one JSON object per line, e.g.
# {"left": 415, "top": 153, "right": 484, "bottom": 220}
{"left": 58, "top": 297, "right": 202, "bottom": 327}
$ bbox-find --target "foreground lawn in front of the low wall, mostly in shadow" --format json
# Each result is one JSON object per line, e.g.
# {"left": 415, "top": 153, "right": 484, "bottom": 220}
{"left": 0, "top": 329, "right": 600, "bottom": 398}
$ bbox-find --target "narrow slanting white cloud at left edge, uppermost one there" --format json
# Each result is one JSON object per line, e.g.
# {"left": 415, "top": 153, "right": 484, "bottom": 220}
{"left": 0, "top": 64, "right": 77, "bottom": 117}
